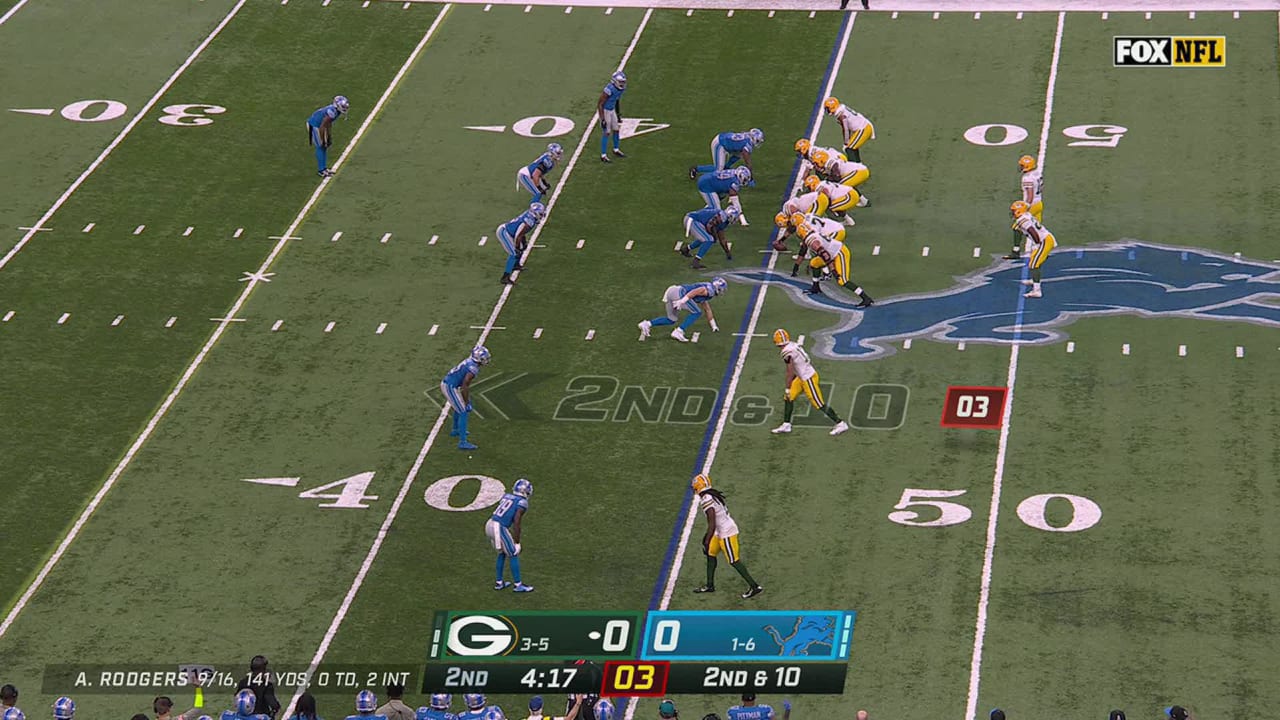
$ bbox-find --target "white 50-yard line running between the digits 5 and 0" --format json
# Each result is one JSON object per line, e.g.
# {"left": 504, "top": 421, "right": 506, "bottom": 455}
{"left": 965, "top": 13, "right": 1066, "bottom": 720}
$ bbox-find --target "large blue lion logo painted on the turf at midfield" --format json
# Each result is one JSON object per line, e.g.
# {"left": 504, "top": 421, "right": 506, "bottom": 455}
{"left": 726, "top": 241, "right": 1280, "bottom": 360}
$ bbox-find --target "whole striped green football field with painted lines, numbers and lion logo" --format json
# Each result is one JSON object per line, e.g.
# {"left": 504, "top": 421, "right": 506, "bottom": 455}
{"left": 0, "top": 0, "right": 1280, "bottom": 720}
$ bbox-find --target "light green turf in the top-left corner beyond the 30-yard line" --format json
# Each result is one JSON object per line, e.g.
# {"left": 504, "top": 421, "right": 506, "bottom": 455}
{"left": 0, "top": 0, "right": 244, "bottom": 229}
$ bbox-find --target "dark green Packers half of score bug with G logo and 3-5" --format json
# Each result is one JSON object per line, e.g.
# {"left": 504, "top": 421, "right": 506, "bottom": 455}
{"left": 430, "top": 611, "right": 641, "bottom": 660}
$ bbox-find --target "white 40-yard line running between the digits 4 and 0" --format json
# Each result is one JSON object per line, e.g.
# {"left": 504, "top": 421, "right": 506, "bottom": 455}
{"left": 284, "top": 5, "right": 653, "bottom": 716}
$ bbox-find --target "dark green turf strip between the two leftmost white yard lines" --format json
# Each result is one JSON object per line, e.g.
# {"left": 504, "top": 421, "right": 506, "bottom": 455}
{"left": 0, "top": 0, "right": 434, "bottom": 638}
